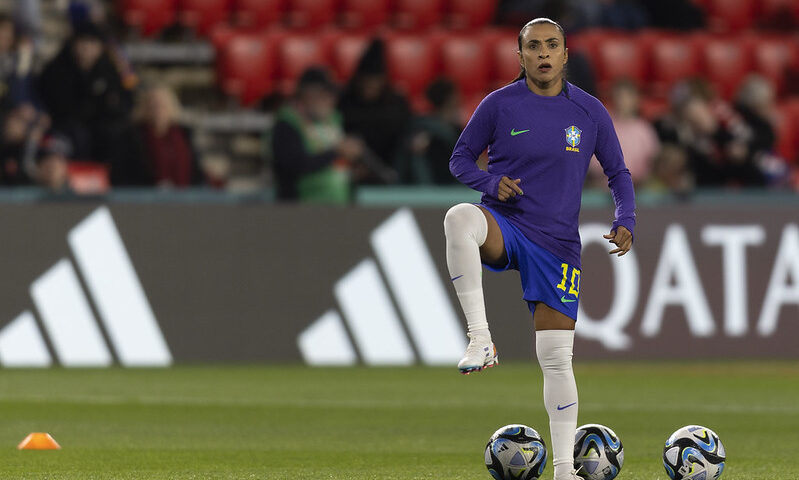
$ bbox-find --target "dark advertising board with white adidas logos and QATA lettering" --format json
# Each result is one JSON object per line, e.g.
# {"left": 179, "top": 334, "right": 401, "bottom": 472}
{"left": 0, "top": 203, "right": 799, "bottom": 365}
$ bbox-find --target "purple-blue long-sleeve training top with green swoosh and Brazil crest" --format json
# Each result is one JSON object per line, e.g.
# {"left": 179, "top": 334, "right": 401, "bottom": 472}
{"left": 449, "top": 79, "right": 635, "bottom": 268}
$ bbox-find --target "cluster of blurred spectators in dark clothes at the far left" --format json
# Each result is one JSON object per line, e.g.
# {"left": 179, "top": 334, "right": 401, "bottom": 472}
{"left": 0, "top": 2, "right": 203, "bottom": 195}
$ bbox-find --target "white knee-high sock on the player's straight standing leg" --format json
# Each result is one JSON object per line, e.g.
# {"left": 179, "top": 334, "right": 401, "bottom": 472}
{"left": 535, "top": 330, "right": 578, "bottom": 480}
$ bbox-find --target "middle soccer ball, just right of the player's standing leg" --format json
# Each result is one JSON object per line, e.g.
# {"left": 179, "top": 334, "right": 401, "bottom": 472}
{"left": 574, "top": 423, "right": 624, "bottom": 480}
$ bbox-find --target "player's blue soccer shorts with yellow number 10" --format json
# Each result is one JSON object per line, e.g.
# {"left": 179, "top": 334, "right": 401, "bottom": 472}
{"left": 480, "top": 205, "right": 580, "bottom": 321}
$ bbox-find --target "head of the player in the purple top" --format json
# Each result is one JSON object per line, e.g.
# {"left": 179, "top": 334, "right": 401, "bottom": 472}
{"left": 519, "top": 23, "right": 569, "bottom": 86}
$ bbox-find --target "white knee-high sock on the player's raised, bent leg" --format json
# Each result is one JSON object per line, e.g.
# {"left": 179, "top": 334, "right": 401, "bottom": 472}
{"left": 444, "top": 203, "right": 490, "bottom": 335}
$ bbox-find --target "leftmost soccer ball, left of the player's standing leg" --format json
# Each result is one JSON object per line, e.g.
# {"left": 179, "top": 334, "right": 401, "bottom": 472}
{"left": 485, "top": 425, "right": 547, "bottom": 480}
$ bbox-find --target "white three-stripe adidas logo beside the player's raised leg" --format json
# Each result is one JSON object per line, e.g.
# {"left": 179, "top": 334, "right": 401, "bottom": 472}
{"left": 297, "top": 209, "right": 466, "bottom": 365}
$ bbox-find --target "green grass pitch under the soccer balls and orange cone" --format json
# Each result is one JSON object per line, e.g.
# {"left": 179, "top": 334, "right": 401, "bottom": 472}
{"left": 0, "top": 362, "right": 799, "bottom": 480}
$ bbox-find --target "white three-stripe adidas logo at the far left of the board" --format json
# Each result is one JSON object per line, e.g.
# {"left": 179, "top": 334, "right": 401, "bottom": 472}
{"left": 0, "top": 207, "right": 172, "bottom": 367}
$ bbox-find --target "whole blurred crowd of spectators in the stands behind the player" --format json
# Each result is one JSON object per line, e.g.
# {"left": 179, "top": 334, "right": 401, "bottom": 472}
{"left": 0, "top": 0, "right": 799, "bottom": 203}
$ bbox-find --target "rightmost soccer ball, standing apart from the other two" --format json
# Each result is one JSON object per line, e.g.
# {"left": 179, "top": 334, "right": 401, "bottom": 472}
{"left": 663, "top": 425, "right": 727, "bottom": 480}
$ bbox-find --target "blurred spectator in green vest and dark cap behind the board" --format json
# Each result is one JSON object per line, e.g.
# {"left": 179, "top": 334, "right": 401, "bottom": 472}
{"left": 267, "top": 68, "right": 364, "bottom": 204}
